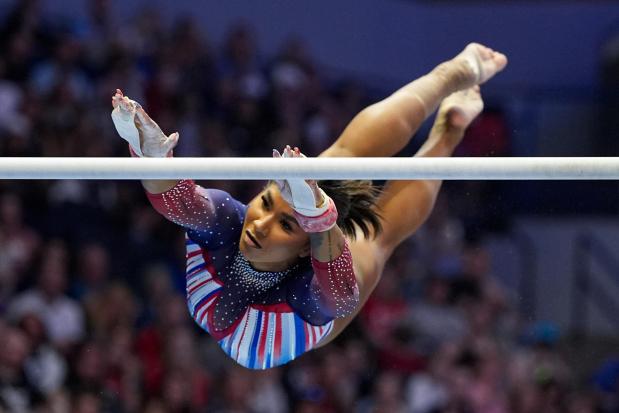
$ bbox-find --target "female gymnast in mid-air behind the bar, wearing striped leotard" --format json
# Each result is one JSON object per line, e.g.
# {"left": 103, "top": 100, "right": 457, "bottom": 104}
{"left": 112, "top": 43, "right": 507, "bottom": 369}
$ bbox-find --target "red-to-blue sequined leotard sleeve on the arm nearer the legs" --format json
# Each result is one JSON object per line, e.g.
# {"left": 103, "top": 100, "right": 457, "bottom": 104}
{"left": 288, "top": 243, "right": 359, "bottom": 325}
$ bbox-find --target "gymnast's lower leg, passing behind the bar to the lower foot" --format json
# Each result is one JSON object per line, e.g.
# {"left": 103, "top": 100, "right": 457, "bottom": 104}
{"left": 320, "top": 86, "right": 483, "bottom": 346}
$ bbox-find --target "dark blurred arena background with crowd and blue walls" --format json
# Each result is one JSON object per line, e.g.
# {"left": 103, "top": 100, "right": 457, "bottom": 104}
{"left": 0, "top": 0, "right": 619, "bottom": 413}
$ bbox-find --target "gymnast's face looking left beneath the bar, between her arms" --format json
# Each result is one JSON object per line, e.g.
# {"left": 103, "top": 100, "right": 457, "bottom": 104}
{"left": 239, "top": 184, "right": 310, "bottom": 271}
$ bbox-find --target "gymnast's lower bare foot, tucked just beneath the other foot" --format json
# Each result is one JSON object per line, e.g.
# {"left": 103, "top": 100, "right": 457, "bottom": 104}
{"left": 432, "top": 86, "right": 484, "bottom": 145}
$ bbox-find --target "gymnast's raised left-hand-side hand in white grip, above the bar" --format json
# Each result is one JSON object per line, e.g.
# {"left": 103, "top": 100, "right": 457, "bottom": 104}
{"left": 112, "top": 89, "right": 179, "bottom": 158}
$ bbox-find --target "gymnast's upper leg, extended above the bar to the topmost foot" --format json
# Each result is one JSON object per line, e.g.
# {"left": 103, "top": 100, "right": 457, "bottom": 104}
{"left": 320, "top": 43, "right": 507, "bottom": 157}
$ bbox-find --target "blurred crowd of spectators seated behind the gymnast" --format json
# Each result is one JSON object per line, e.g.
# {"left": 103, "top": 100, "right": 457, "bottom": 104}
{"left": 0, "top": 0, "right": 619, "bottom": 413}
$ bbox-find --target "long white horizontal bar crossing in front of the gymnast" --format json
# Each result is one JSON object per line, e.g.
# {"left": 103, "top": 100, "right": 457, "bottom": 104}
{"left": 0, "top": 157, "right": 619, "bottom": 180}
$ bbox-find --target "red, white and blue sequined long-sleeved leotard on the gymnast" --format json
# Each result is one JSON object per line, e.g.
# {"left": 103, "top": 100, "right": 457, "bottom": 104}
{"left": 147, "top": 180, "right": 359, "bottom": 369}
